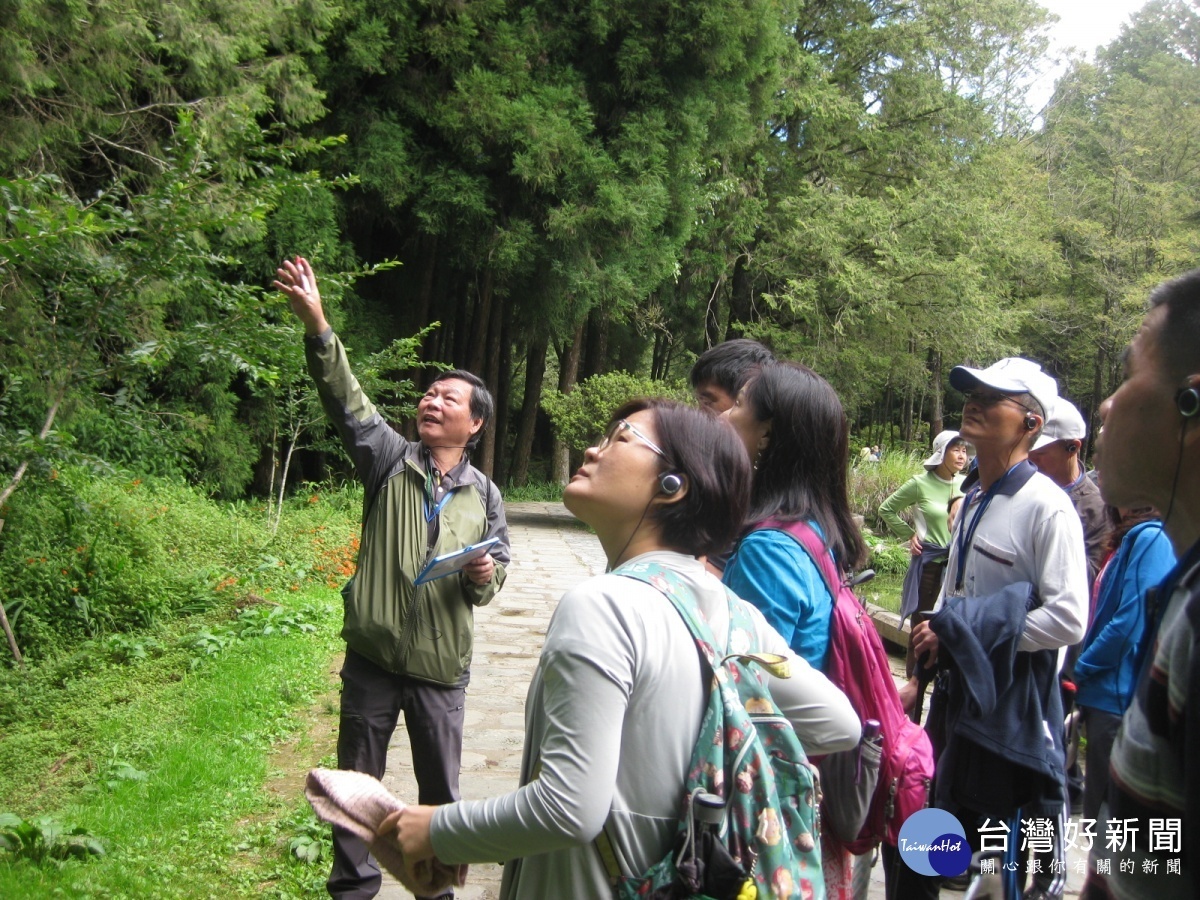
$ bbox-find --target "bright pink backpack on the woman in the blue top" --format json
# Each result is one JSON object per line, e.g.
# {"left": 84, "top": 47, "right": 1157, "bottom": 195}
{"left": 763, "top": 522, "right": 934, "bottom": 854}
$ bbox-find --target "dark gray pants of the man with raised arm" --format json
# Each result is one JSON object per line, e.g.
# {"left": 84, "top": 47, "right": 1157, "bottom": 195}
{"left": 326, "top": 648, "right": 467, "bottom": 900}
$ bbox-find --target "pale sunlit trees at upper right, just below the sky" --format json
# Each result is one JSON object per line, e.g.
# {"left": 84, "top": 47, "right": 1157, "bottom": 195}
{"left": 1022, "top": 0, "right": 1200, "bottom": 422}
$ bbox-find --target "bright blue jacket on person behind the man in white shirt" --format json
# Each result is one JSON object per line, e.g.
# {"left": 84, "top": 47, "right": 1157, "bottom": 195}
{"left": 1075, "top": 521, "right": 1175, "bottom": 715}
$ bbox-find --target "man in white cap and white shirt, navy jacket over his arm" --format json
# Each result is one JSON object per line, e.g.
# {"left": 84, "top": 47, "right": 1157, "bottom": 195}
{"left": 888, "top": 358, "right": 1087, "bottom": 900}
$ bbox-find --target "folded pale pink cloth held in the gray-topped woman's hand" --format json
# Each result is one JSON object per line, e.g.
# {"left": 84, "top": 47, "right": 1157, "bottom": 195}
{"left": 304, "top": 769, "right": 467, "bottom": 896}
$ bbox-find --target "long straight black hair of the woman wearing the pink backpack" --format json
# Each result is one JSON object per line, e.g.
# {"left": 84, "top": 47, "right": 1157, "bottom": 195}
{"left": 746, "top": 362, "right": 866, "bottom": 569}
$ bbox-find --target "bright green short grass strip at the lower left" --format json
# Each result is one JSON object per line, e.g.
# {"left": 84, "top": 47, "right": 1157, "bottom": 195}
{"left": 0, "top": 588, "right": 337, "bottom": 898}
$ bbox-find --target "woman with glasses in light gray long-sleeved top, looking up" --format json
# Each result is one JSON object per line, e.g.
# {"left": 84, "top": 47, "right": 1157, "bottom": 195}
{"left": 369, "top": 400, "right": 859, "bottom": 900}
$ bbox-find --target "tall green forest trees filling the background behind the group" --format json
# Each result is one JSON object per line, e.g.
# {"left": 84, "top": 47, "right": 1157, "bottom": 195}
{"left": 0, "top": 0, "right": 1200, "bottom": 644}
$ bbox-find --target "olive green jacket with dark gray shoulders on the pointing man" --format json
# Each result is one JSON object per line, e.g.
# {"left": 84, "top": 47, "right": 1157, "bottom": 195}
{"left": 305, "top": 330, "right": 510, "bottom": 685}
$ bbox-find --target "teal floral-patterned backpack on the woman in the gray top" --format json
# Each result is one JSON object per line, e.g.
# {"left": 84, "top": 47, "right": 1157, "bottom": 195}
{"left": 596, "top": 563, "right": 824, "bottom": 900}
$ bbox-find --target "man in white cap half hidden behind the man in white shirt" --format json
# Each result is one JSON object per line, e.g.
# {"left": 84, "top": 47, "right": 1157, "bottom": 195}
{"left": 1030, "top": 397, "right": 1112, "bottom": 589}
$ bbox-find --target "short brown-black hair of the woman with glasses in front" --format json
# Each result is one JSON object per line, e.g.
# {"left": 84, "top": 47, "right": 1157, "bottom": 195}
{"left": 610, "top": 397, "right": 750, "bottom": 556}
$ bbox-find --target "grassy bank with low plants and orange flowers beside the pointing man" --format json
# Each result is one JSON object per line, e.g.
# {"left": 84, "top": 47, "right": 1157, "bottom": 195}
{"left": 0, "top": 476, "right": 361, "bottom": 900}
